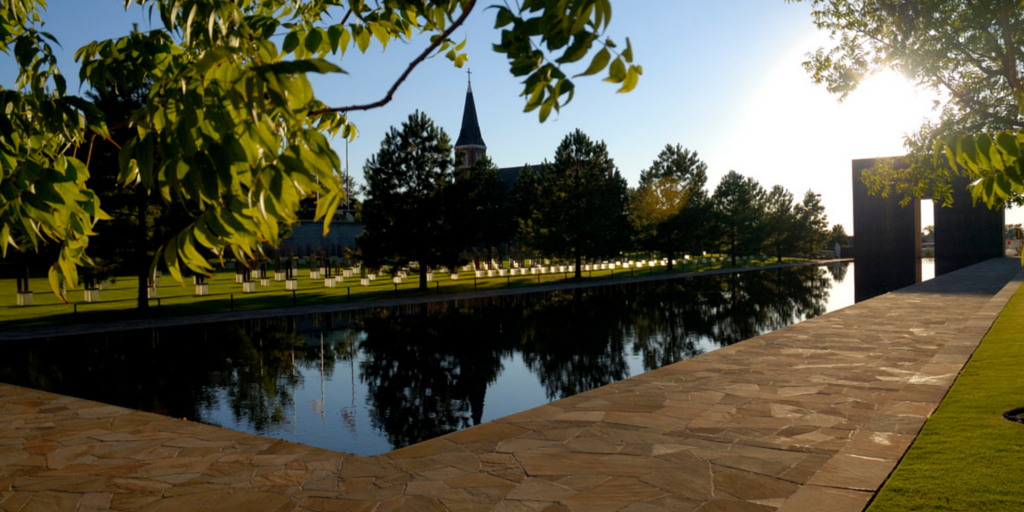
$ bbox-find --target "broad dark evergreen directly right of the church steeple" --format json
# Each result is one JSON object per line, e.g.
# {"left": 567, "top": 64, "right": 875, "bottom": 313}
{"left": 526, "top": 129, "right": 630, "bottom": 279}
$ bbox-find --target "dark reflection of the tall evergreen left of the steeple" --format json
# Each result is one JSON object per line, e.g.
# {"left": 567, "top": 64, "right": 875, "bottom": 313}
{"left": 359, "top": 310, "right": 509, "bottom": 447}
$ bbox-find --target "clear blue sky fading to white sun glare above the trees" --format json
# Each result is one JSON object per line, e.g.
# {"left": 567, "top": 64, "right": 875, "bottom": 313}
{"left": 6, "top": 0, "right": 1024, "bottom": 233}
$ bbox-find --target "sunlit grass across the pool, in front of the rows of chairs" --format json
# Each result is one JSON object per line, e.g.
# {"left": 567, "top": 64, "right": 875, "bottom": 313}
{"left": 0, "top": 254, "right": 795, "bottom": 329}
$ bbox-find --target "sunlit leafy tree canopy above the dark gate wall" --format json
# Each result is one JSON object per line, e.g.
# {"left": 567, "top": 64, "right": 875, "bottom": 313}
{"left": 786, "top": 0, "right": 1024, "bottom": 207}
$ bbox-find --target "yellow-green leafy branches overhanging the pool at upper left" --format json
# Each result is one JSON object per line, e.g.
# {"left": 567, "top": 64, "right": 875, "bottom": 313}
{"left": 0, "top": 0, "right": 642, "bottom": 295}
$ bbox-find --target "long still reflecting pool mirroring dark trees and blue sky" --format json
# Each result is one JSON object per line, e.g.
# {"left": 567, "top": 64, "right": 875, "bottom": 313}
{"left": 0, "top": 263, "right": 888, "bottom": 456}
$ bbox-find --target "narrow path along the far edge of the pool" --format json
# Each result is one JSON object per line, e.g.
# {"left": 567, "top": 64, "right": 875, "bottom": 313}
{"left": 0, "top": 258, "right": 853, "bottom": 341}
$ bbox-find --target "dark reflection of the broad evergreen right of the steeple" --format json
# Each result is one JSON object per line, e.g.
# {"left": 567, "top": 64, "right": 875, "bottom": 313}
{"left": 518, "top": 290, "right": 630, "bottom": 400}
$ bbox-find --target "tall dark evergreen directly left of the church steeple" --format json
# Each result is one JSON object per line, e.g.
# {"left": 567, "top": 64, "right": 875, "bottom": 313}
{"left": 358, "top": 112, "right": 466, "bottom": 290}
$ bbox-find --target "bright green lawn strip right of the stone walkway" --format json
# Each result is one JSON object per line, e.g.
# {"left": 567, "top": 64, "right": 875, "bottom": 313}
{"left": 868, "top": 288, "right": 1024, "bottom": 512}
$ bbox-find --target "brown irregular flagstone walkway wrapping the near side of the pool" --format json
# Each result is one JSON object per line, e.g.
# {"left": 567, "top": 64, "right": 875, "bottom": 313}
{"left": 0, "top": 259, "right": 1022, "bottom": 512}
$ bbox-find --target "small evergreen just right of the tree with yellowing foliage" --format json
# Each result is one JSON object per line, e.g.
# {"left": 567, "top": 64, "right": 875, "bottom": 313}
{"left": 713, "top": 171, "right": 765, "bottom": 266}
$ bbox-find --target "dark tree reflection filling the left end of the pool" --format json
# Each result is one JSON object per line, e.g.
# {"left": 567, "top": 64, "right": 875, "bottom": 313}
{"left": 0, "top": 321, "right": 348, "bottom": 432}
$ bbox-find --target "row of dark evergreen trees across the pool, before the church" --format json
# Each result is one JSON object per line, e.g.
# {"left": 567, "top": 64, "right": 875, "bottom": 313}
{"left": 358, "top": 112, "right": 829, "bottom": 288}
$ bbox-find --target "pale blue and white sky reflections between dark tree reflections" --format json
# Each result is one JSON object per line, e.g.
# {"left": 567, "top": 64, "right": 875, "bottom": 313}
{"left": 202, "top": 260, "right": 856, "bottom": 455}
